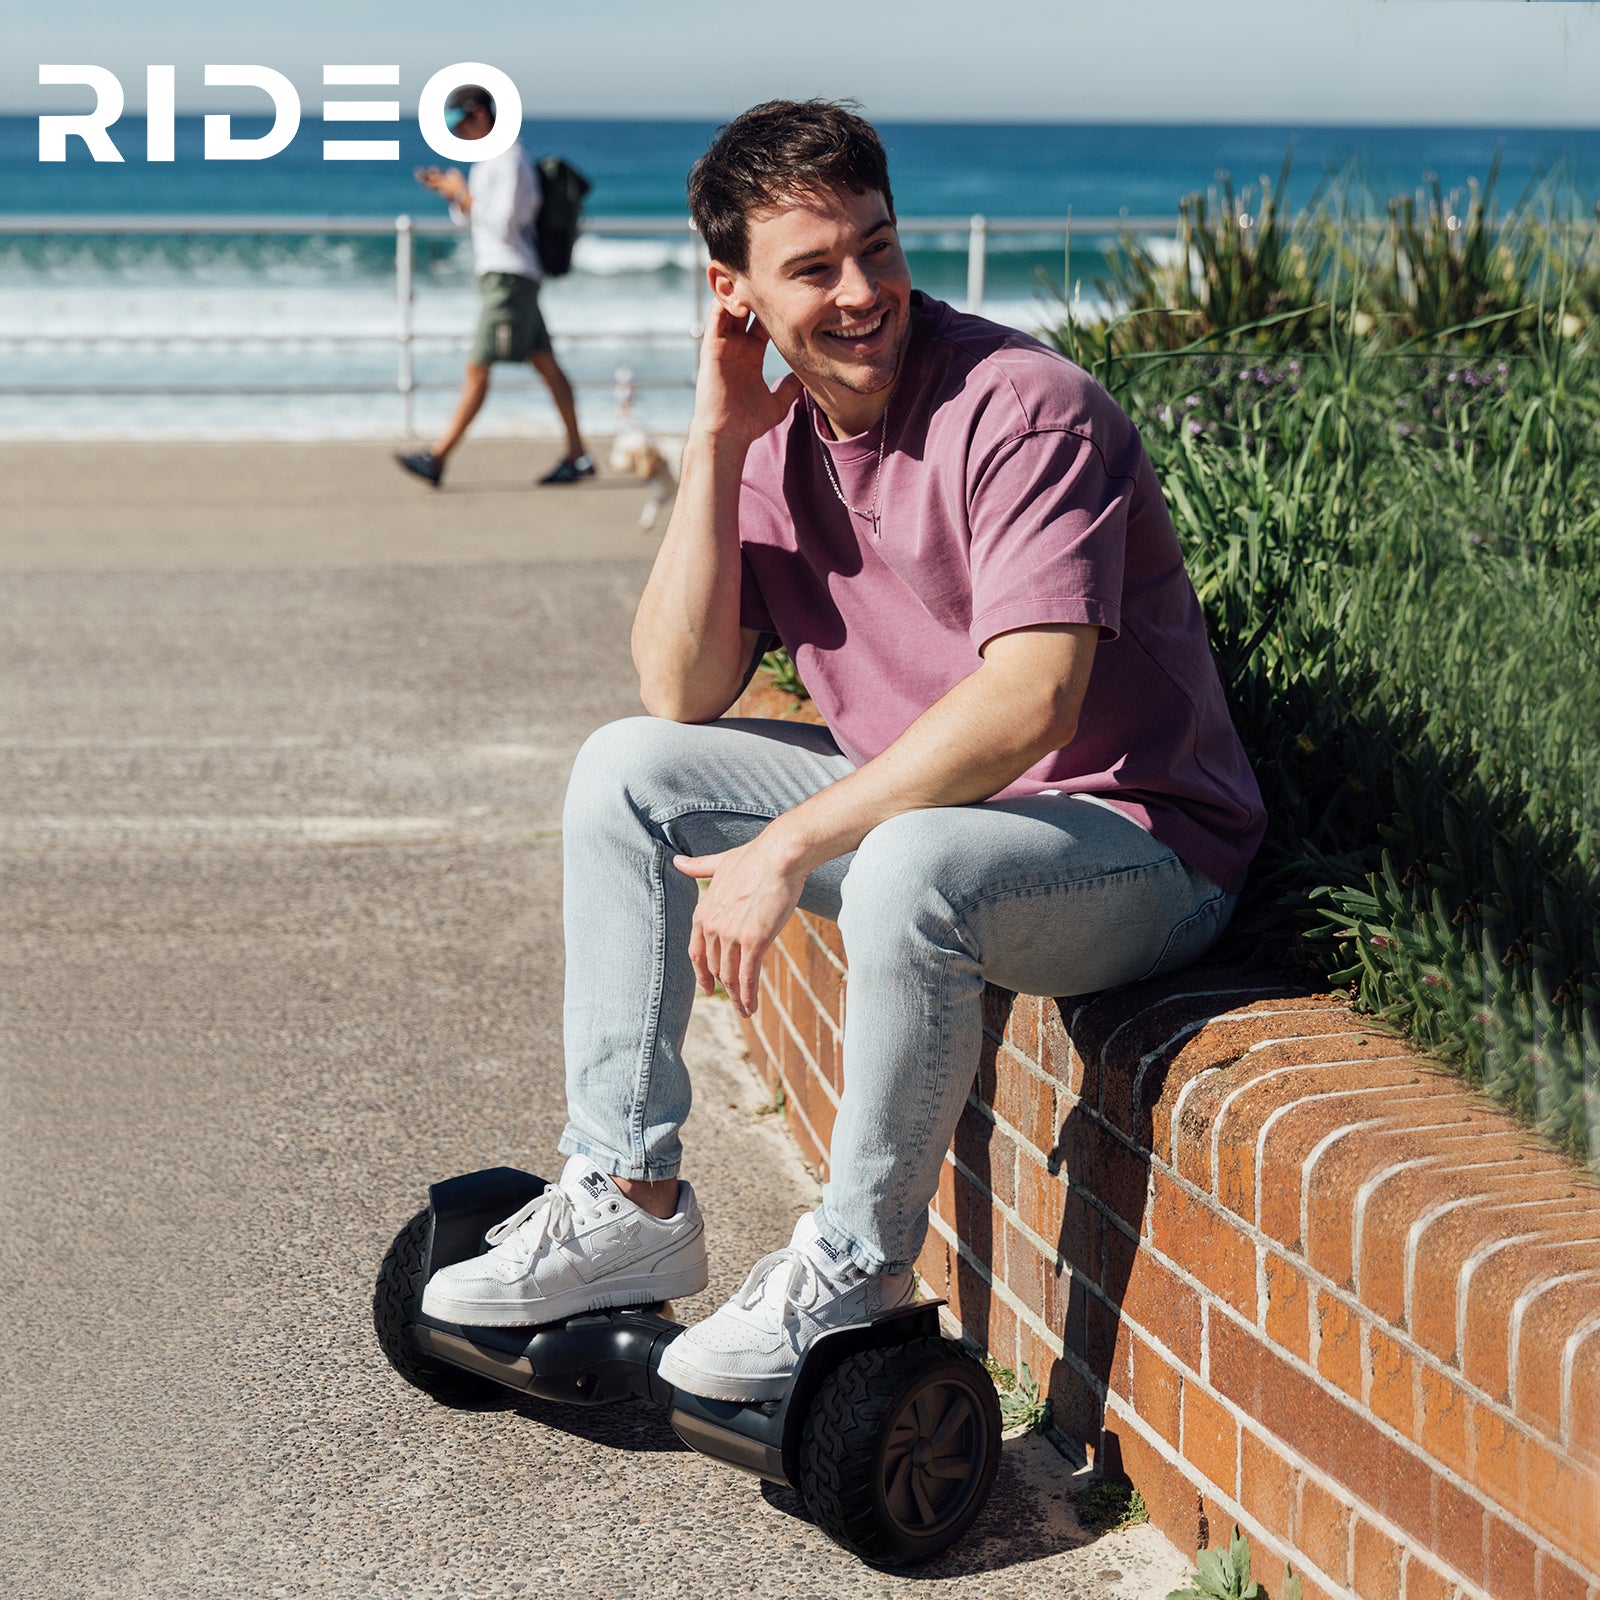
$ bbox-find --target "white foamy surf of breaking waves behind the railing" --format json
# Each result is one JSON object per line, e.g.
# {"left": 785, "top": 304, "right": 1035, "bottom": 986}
{"left": 0, "top": 260, "right": 1048, "bottom": 438}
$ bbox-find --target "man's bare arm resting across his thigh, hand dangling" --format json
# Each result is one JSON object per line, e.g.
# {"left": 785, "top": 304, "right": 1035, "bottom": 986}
{"left": 674, "top": 624, "right": 1099, "bottom": 1016}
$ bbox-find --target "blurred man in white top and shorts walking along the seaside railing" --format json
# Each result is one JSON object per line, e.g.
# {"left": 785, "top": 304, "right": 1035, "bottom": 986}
{"left": 395, "top": 83, "right": 595, "bottom": 488}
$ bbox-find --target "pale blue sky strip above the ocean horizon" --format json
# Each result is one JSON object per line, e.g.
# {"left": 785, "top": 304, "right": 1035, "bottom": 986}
{"left": 9, "top": 0, "right": 1600, "bottom": 126}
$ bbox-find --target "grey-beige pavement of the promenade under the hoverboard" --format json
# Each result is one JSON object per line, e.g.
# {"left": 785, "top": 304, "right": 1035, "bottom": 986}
{"left": 0, "top": 442, "right": 1186, "bottom": 1600}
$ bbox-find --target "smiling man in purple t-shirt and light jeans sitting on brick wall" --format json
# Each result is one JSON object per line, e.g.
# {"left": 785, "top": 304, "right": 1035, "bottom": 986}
{"left": 424, "top": 102, "right": 1264, "bottom": 1400}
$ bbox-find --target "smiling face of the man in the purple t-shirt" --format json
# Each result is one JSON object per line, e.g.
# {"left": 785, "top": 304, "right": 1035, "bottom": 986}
{"left": 718, "top": 189, "right": 910, "bottom": 422}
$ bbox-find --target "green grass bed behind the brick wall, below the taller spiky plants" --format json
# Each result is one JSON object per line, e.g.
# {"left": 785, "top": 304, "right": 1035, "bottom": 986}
{"left": 1056, "top": 200, "right": 1600, "bottom": 1160}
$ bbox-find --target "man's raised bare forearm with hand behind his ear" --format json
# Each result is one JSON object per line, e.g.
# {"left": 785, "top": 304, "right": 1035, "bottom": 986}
{"left": 632, "top": 306, "right": 800, "bottom": 722}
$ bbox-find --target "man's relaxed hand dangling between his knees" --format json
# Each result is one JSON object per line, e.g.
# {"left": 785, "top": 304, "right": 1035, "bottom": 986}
{"left": 672, "top": 834, "right": 806, "bottom": 1016}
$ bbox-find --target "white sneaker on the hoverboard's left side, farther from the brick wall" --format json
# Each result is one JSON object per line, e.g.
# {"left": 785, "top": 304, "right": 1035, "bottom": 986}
{"left": 422, "top": 1155, "right": 707, "bottom": 1328}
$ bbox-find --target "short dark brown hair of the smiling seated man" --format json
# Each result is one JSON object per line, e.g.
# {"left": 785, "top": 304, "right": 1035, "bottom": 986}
{"left": 690, "top": 99, "right": 894, "bottom": 272}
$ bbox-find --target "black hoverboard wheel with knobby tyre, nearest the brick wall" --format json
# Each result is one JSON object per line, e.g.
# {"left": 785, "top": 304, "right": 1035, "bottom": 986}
{"left": 800, "top": 1338, "right": 1002, "bottom": 1566}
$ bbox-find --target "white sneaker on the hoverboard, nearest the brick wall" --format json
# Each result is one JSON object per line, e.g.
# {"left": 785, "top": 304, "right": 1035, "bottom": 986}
{"left": 661, "top": 1213, "right": 915, "bottom": 1400}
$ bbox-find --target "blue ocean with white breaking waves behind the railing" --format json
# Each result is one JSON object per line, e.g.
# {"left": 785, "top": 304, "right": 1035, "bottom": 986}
{"left": 0, "top": 117, "right": 1600, "bottom": 438}
